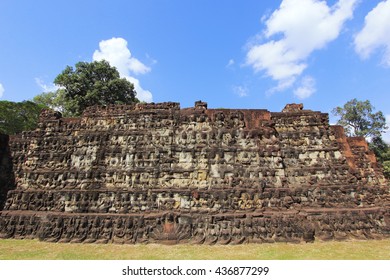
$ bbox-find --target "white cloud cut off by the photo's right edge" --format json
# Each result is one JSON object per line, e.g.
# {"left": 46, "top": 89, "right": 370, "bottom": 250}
{"left": 354, "top": 0, "right": 390, "bottom": 67}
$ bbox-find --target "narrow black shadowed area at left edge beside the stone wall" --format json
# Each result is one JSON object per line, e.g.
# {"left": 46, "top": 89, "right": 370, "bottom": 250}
{"left": 0, "top": 134, "right": 15, "bottom": 211}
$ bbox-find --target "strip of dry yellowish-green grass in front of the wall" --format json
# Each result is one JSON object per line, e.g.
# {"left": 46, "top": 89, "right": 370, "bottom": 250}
{"left": 0, "top": 239, "right": 390, "bottom": 260}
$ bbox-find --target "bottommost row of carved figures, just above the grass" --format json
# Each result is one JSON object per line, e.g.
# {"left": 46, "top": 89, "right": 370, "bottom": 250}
{"left": 0, "top": 213, "right": 390, "bottom": 244}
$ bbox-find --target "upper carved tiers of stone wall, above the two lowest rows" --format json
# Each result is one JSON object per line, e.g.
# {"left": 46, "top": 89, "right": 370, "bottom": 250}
{"left": 8, "top": 103, "right": 384, "bottom": 190}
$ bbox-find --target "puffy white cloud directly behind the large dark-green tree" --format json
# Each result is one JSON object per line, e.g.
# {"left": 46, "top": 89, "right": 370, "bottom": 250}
{"left": 93, "top": 38, "right": 153, "bottom": 102}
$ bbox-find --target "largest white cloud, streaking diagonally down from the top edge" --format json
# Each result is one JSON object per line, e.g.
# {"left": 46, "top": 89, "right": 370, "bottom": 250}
{"left": 246, "top": 0, "right": 358, "bottom": 96}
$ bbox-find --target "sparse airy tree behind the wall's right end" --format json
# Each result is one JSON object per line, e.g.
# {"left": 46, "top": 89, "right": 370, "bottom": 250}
{"left": 332, "top": 98, "right": 387, "bottom": 137}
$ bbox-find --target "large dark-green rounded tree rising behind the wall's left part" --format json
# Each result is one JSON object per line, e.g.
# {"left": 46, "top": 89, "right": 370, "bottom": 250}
{"left": 54, "top": 60, "right": 138, "bottom": 116}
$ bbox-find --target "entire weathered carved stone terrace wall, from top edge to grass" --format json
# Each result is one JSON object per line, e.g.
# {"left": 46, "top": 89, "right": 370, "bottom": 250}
{"left": 0, "top": 101, "right": 390, "bottom": 244}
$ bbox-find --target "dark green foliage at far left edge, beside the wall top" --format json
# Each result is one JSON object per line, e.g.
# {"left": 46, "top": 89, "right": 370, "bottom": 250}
{"left": 0, "top": 101, "right": 45, "bottom": 135}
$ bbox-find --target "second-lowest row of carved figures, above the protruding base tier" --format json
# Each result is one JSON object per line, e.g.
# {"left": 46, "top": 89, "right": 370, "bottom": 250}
{"left": 4, "top": 187, "right": 390, "bottom": 214}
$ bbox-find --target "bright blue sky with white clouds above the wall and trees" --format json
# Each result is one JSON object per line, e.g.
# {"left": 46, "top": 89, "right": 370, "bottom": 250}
{"left": 0, "top": 0, "right": 390, "bottom": 139}
